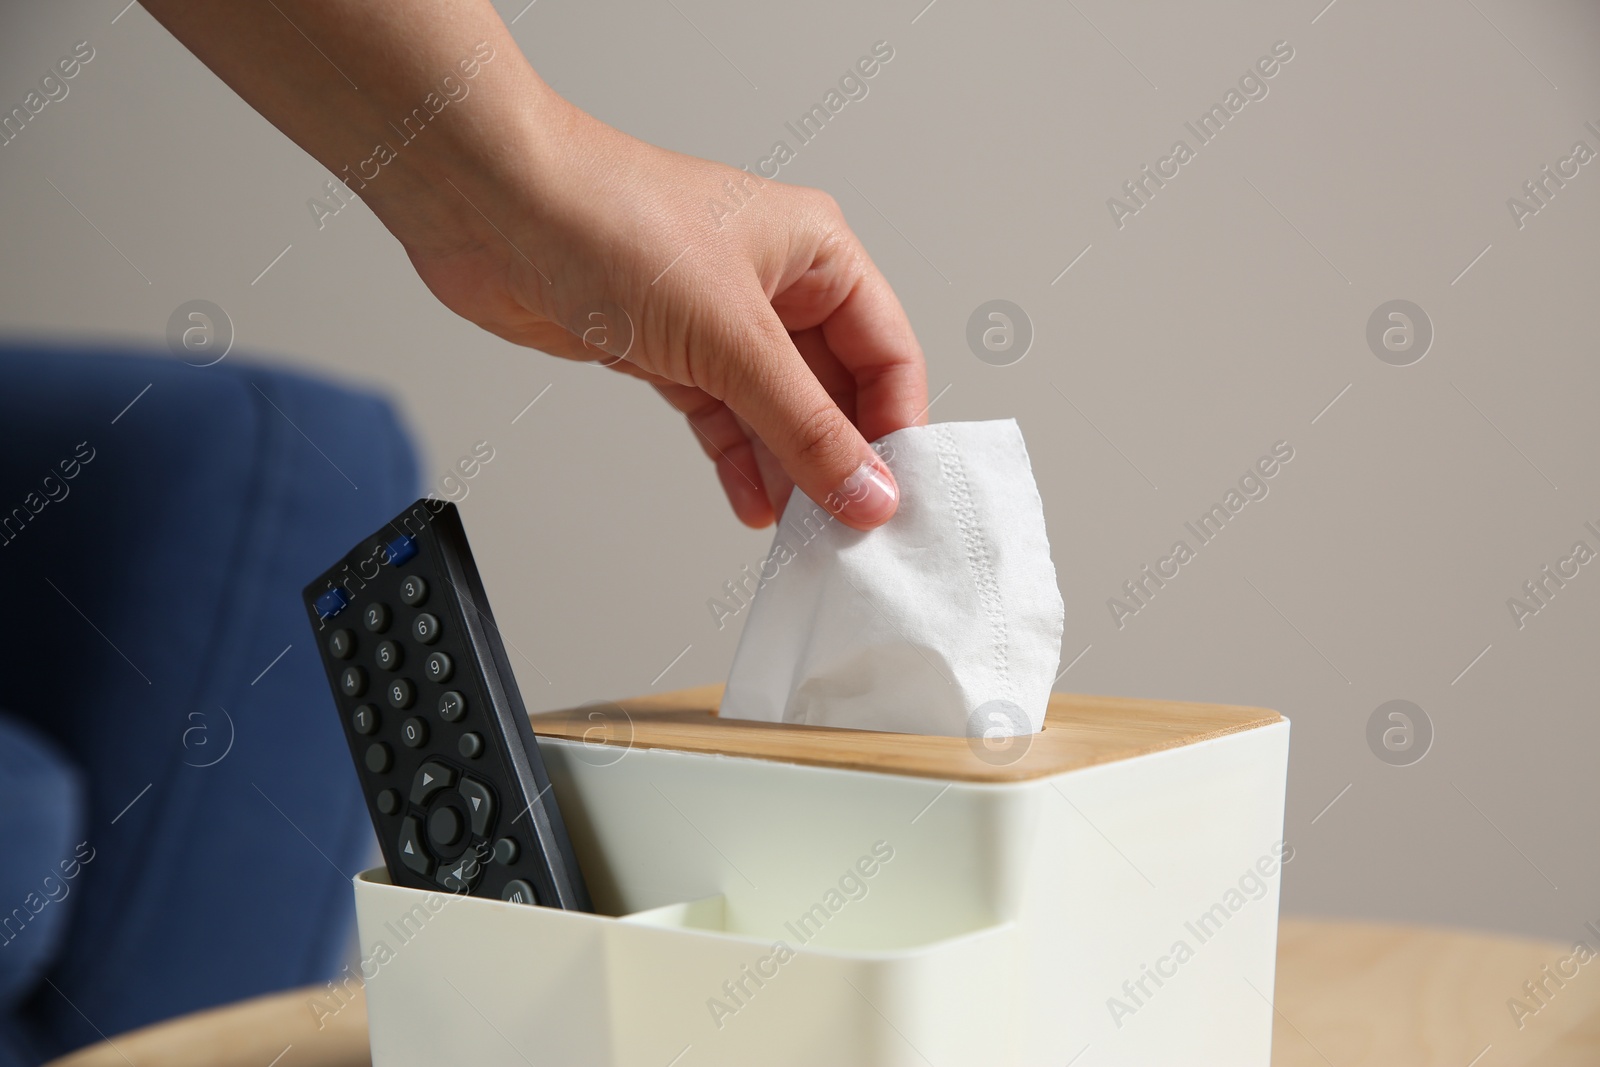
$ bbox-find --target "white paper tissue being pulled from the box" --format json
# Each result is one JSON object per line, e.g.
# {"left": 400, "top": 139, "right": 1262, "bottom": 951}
{"left": 720, "top": 419, "right": 1064, "bottom": 736}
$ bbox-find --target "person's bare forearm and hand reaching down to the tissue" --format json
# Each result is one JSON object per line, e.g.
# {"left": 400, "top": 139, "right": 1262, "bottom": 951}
{"left": 146, "top": 0, "right": 926, "bottom": 530}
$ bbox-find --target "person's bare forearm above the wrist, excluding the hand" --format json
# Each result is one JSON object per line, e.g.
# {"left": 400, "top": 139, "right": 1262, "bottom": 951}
{"left": 144, "top": 0, "right": 573, "bottom": 251}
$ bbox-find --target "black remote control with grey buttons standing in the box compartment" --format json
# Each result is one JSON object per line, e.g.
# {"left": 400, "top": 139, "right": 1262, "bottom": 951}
{"left": 304, "top": 498, "right": 594, "bottom": 912}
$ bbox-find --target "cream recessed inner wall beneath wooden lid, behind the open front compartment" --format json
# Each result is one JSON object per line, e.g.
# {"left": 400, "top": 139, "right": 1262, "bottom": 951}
{"left": 541, "top": 739, "right": 1040, "bottom": 952}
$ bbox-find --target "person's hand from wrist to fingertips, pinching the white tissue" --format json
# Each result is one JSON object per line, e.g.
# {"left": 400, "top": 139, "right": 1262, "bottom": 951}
{"left": 390, "top": 106, "right": 928, "bottom": 530}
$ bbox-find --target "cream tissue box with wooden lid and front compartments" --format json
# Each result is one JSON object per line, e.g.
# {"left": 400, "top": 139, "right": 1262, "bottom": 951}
{"left": 355, "top": 686, "right": 1293, "bottom": 1067}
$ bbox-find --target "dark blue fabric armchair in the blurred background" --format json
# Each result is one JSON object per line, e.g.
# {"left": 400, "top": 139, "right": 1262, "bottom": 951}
{"left": 0, "top": 346, "right": 418, "bottom": 1062}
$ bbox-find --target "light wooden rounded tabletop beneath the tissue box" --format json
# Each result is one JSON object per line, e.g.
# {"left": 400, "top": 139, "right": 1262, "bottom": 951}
{"left": 51, "top": 918, "right": 1600, "bottom": 1067}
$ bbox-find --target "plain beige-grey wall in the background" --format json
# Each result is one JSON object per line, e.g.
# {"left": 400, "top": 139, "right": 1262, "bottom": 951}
{"left": 0, "top": 0, "right": 1600, "bottom": 940}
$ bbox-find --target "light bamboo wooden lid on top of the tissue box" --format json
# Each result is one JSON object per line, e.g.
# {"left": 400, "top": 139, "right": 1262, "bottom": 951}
{"left": 530, "top": 685, "right": 1282, "bottom": 782}
